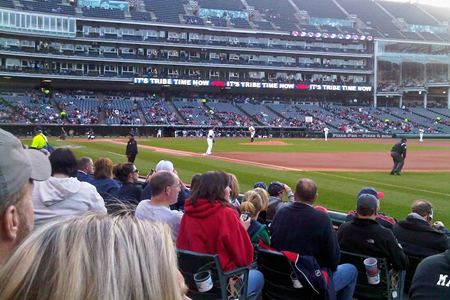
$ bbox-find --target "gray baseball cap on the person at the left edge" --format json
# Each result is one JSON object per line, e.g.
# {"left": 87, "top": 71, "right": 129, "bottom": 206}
{"left": 0, "top": 129, "right": 52, "bottom": 199}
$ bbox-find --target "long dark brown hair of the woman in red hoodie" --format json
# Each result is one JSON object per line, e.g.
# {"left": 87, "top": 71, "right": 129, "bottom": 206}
{"left": 189, "top": 171, "right": 230, "bottom": 206}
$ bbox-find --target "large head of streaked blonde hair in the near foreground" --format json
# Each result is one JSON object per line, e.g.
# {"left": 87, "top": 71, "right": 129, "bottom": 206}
{"left": 0, "top": 213, "right": 182, "bottom": 300}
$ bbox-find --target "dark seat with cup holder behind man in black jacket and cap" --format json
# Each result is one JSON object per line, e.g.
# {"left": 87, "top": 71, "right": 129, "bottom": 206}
{"left": 340, "top": 251, "right": 403, "bottom": 300}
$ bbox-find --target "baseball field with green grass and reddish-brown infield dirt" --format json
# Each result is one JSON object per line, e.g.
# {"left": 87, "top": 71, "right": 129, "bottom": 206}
{"left": 24, "top": 138, "right": 450, "bottom": 226}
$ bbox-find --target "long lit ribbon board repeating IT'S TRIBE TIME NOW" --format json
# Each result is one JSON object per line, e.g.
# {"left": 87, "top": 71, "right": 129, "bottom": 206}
{"left": 133, "top": 78, "right": 372, "bottom": 92}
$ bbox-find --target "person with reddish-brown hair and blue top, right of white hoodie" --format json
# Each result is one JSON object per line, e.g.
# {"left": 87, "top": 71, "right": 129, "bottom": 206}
{"left": 92, "top": 158, "right": 120, "bottom": 200}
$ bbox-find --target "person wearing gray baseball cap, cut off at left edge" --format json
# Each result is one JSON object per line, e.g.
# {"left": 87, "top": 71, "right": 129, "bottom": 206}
{"left": 0, "top": 129, "right": 52, "bottom": 265}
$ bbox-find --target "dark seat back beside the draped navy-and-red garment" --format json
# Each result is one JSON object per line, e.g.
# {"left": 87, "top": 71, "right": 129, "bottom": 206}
{"left": 258, "top": 247, "right": 320, "bottom": 300}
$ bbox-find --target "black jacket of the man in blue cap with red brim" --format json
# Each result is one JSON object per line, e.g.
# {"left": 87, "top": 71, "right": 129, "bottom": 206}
{"left": 337, "top": 217, "right": 408, "bottom": 270}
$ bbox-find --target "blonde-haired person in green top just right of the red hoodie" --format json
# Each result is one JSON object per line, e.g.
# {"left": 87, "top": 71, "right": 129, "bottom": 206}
{"left": 240, "top": 190, "right": 270, "bottom": 246}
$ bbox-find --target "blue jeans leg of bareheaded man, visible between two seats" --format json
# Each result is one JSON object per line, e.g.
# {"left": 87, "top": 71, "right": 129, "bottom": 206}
{"left": 333, "top": 264, "right": 358, "bottom": 300}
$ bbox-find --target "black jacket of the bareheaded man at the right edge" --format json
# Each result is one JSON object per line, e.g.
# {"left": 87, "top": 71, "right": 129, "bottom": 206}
{"left": 392, "top": 215, "right": 450, "bottom": 257}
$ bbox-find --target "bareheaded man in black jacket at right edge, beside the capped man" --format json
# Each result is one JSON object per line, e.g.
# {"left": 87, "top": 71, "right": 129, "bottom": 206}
{"left": 392, "top": 200, "right": 450, "bottom": 257}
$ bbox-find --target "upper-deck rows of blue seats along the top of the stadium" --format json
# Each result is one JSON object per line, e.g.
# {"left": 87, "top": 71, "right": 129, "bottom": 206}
{"left": 0, "top": 0, "right": 450, "bottom": 41}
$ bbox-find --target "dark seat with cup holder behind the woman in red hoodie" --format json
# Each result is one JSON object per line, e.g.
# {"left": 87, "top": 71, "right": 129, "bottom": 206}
{"left": 177, "top": 249, "right": 248, "bottom": 300}
